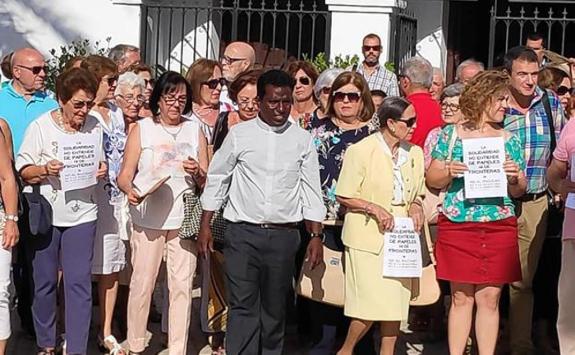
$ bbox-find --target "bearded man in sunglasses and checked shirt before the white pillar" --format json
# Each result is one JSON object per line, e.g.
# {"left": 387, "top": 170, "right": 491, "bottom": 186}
{"left": 357, "top": 33, "right": 399, "bottom": 96}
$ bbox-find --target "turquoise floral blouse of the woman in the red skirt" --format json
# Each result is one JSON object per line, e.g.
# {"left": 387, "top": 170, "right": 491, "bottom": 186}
{"left": 432, "top": 125, "right": 525, "bottom": 222}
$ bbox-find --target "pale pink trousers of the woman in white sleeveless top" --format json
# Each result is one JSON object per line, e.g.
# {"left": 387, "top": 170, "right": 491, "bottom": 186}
{"left": 128, "top": 226, "right": 197, "bottom": 355}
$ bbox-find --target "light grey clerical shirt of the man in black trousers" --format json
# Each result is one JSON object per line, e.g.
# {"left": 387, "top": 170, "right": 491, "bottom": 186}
{"left": 201, "top": 117, "right": 326, "bottom": 224}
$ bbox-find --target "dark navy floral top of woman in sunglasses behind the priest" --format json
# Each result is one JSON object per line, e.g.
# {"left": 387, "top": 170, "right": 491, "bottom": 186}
{"left": 310, "top": 118, "right": 373, "bottom": 221}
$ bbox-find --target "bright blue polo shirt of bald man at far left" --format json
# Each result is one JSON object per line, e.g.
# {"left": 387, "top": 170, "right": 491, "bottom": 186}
{"left": 0, "top": 82, "right": 58, "bottom": 155}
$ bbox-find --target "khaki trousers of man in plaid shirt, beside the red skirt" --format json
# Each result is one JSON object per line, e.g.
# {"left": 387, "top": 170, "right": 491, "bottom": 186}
{"left": 509, "top": 196, "right": 548, "bottom": 355}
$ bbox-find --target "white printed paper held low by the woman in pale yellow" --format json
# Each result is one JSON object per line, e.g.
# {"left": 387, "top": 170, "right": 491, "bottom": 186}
{"left": 383, "top": 218, "right": 422, "bottom": 277}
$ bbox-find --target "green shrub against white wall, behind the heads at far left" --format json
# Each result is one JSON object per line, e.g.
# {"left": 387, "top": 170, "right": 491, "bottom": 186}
{"left": 46, "top": 37, "right": 111, "bottom": 91}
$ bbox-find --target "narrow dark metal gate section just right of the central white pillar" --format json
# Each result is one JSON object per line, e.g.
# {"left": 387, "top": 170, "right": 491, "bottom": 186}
{"left": 389, "top": 8, "right": 417, "bottom": 70}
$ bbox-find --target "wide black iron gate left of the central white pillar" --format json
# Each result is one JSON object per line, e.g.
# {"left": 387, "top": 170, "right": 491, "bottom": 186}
{"left": 140, "top": 0, "right": 331, "bottom": 72}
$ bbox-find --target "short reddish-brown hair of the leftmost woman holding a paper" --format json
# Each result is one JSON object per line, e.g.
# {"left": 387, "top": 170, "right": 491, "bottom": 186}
{"left": 56, "top": 68, "right": 99, "bottom": 104}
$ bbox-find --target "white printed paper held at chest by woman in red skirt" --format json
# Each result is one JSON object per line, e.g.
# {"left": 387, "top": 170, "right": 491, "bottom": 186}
{"left": 462, "top": 137, "right": 507, "bottom": 199}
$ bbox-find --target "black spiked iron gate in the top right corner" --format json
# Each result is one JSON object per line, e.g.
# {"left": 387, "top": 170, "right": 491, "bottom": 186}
{"left": 488, "top": 0, "right": 575, "bottom": 67}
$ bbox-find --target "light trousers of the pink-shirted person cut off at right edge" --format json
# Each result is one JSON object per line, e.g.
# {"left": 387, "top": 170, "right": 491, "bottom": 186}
{"left": 557, "top": 239, "right": 575, "bottom": 355}
